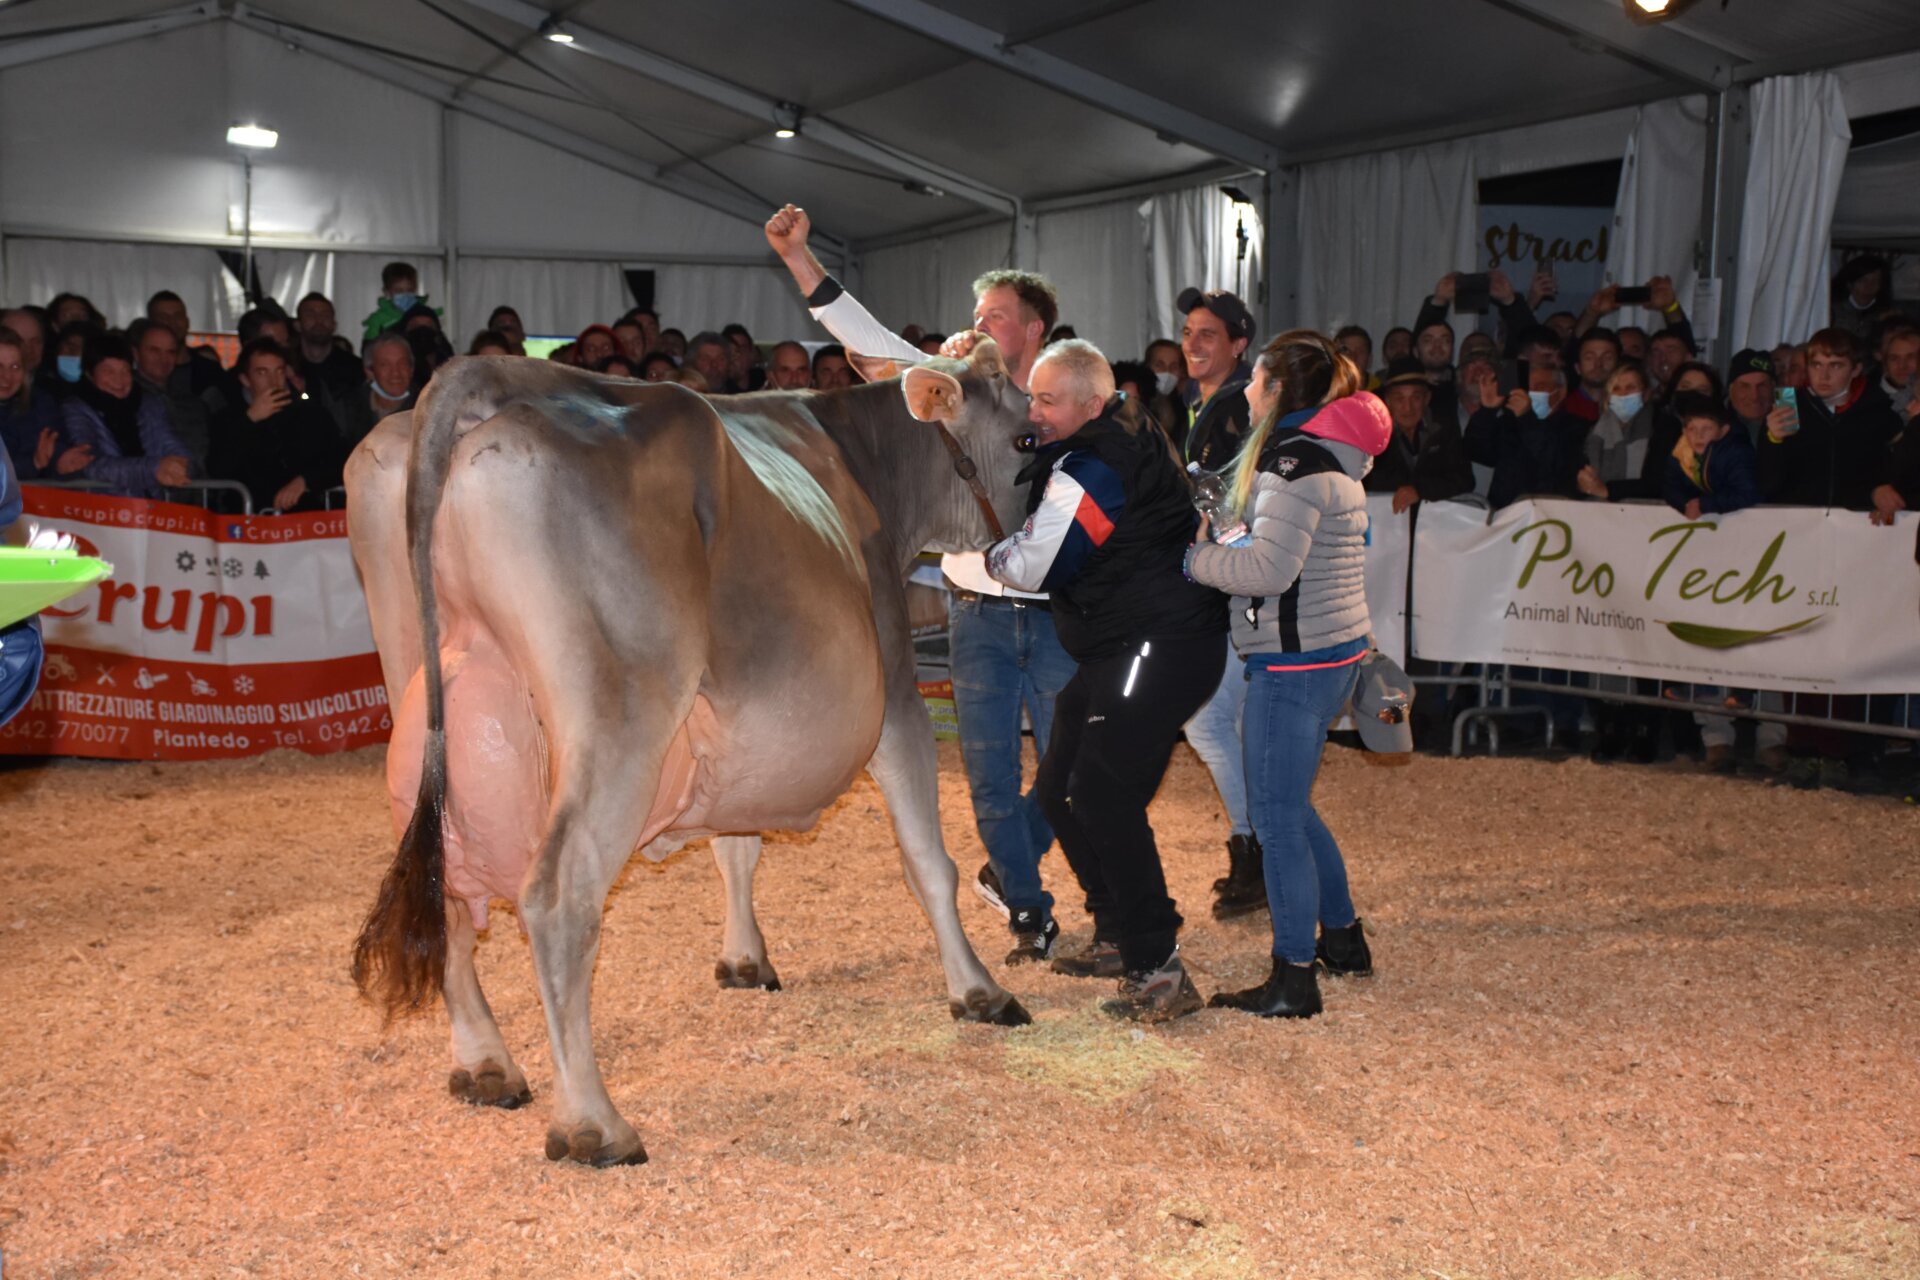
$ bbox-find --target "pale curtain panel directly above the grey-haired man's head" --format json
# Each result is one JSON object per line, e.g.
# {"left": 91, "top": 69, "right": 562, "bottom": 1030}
{"left": 1035, "top": 200, "right": 1152, "bottom": 361}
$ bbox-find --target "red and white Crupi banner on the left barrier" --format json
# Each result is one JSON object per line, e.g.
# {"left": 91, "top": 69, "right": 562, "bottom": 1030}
{"left": 0, "top": 486, "right": 392, "bottom": 760}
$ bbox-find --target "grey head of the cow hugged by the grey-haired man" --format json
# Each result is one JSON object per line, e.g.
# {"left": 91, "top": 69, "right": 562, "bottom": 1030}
{"left": 883, "top": 340, "right": 1031, "bottom": 551}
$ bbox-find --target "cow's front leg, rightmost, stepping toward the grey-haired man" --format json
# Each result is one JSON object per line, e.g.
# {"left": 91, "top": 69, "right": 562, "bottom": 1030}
{"left": 868, "top": 679, "right": 1033, "bottom": 1027}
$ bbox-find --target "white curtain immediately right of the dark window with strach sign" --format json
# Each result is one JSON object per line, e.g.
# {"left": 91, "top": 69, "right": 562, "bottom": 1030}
{"left": 1607, "top": 94, "right": 1707, "bottom": 330}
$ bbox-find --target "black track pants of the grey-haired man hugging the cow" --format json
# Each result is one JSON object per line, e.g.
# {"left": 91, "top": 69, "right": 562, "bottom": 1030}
{"left": 1035, "top": 635, "right": 1227, "bottom": 969}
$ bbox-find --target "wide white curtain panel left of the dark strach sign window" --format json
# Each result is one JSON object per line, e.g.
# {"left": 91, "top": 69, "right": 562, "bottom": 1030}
{"left": 1300, "top": 142, "right": 1478, "bottom": 344}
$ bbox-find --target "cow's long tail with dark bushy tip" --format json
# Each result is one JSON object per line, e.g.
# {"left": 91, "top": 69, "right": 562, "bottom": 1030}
{"left": 353, "top": 361, "right": 493, "bottom": 1023}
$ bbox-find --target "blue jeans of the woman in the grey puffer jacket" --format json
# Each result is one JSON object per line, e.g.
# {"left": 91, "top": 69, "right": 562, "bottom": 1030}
{"left": 1246, "top": 658, "right": 1359, "bottom": 965}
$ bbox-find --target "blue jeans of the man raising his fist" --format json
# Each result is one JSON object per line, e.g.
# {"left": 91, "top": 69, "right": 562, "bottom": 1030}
{"left": 947, "top": 597, "right": 1079, "bottom": 912}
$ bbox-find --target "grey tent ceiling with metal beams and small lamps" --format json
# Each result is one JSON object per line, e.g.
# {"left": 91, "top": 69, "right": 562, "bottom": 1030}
{"left": 0, "top": 0, "right": 1920, "bottom": 244}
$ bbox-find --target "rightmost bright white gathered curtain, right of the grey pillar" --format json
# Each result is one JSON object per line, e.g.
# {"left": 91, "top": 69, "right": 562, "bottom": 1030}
{"left": 1732, "top": 71, "right": 1853, "bottom": 349}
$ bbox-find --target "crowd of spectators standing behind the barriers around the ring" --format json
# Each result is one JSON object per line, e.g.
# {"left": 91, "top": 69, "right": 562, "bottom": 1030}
{"left": 0, "top": 255, "right": 1920, "bottom": 786}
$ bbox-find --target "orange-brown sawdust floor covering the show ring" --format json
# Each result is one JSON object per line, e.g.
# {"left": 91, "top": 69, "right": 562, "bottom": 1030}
{"left": 0, "top": 747, "right": 1920, "bottom": 1280}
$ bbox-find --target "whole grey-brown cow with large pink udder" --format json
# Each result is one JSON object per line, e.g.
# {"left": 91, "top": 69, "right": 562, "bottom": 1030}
{"left": 348, "top": 344, "right": 1027, "bottom": 1165}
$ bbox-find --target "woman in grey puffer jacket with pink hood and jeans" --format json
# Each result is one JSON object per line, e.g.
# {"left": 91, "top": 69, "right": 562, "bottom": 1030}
{"left": 1187, "top": 330, "right": 1392, "bottom": 1017}
